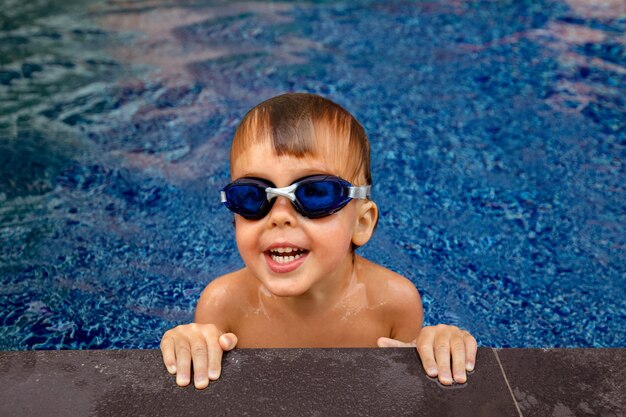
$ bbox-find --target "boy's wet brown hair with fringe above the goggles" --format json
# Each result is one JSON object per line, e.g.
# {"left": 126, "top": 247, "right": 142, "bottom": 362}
{"left": 230, "top": 93, "right": 372, "bottom": 185}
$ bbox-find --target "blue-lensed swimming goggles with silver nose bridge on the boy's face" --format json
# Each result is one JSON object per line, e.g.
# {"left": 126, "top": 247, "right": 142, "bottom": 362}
{"left": 221, "top": 174, "right": 372, "bottom": 220}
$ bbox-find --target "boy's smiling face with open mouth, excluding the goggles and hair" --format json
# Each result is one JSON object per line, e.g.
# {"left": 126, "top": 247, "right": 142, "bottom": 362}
{"left": 231, "top": 143, "right": 376, "bottom": 298}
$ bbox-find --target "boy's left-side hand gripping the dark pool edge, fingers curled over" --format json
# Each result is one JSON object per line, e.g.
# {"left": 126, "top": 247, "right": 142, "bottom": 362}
{"left": 161, "top": 323, "right": 237, "bottom": 389}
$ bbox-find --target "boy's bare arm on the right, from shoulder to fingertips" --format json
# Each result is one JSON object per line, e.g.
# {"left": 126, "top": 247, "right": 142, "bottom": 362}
{"left": 378, "top": 274, "right": 477, "bottom": 385}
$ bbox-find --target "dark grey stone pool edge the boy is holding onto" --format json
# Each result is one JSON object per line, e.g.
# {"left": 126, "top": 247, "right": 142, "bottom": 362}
{"left": 0, "top": 347, "right": 626, "bottom": 417}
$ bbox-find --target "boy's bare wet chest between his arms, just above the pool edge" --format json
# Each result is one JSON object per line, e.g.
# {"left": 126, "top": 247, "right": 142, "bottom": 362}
{"left": 232, "top": 302, "right": 391, "bottom": 348}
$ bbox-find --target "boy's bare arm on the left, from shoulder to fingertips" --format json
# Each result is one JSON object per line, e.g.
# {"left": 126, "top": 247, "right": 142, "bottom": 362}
{"left": 161, "top": 277, "right": 237, "bottom": 389}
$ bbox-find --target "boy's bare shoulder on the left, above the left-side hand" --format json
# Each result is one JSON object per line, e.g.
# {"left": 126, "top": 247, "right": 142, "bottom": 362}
{"left": 194, "top": 269, "right": 255, "bottom": 325}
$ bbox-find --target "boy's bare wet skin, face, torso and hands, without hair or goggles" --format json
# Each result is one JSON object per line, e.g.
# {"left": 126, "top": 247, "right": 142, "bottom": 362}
{"left": 161, "top": 144, "right": 476, "bottom": 388}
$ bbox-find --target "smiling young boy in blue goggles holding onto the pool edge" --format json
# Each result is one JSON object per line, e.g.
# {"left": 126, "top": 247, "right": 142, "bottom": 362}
{"left": 161, "top": 94, "right": 477, "bottom": 389}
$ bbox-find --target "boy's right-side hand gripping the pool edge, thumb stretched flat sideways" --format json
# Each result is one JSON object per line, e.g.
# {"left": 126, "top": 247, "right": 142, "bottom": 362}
{"left": 378, "top": 324, "right": 478, "bottom": 385}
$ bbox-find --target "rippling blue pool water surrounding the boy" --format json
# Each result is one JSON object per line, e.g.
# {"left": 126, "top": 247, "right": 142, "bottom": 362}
{"left": 0, "top": 0, "right": 626, "bottom": 349}
